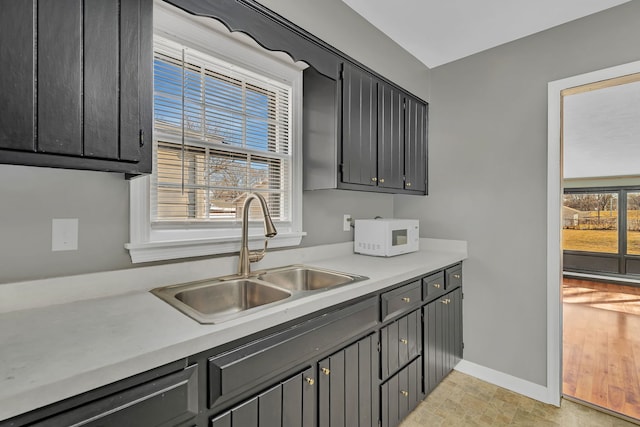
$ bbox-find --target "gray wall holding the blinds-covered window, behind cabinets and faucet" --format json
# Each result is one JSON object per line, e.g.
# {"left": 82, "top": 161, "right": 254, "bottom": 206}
{"left": 0, "top": 0, "right": 429, "bottom": 283}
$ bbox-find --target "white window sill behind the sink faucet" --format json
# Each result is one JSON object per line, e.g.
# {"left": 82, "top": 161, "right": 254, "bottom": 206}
{"left": 125, "top": 232, "right": 306, "bottom": 264}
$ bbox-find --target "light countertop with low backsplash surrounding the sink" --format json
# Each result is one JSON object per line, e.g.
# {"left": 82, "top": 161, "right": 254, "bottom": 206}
{"left": 0, "top": 239, "right": 467, "bottom": 420}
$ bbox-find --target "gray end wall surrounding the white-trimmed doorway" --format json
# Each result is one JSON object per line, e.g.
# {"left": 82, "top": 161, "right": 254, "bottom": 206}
{"left": 394, "top": 1, "right": 640, "bottom": 385}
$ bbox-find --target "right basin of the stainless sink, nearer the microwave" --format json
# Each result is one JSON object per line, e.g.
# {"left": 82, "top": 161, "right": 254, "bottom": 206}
{"left": 258, "top": 265, "right": 366, "bottom": 291}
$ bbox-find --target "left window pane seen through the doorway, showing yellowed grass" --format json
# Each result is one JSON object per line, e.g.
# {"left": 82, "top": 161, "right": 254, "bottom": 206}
{"left": 562, "top": 192, "right": 618, "bottom": 253}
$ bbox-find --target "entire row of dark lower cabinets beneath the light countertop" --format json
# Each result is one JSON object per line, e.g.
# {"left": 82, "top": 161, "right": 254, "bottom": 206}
{"left": 0, "top": 264, "right": 463, "bottom": 427}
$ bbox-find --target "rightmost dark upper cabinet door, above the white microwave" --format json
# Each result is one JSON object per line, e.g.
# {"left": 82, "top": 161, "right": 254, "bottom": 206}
{"left": 404, "top": 96, "right": 428, "bottom": 194}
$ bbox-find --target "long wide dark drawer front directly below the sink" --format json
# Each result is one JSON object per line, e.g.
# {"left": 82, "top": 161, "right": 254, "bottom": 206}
{"left": 208, "top": 298, "right": 378, "bottom": 407}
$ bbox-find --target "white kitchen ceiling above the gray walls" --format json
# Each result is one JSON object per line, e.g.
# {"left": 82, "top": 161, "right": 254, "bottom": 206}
{"left": 342, "top": 0, "right": 629, "bottom": 68}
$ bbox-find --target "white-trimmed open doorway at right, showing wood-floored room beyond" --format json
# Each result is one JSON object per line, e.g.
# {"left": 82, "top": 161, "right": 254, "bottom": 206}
{"left": 548, "top": 68, "right": 640, "bottom": 419}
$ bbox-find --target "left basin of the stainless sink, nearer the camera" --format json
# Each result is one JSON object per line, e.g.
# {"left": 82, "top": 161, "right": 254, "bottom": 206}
{"left": 151, "top": 279, "right": 291, "bottom": 323}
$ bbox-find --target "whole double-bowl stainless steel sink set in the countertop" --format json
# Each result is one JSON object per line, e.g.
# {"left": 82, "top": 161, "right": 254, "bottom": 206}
{"left": 151, "top": 265, "right": 368, "bottom": 323}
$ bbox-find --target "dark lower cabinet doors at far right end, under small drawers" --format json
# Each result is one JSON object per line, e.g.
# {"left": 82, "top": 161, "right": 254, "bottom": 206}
{"left": 424, "top": 288, "right": 462, "bottom": 393}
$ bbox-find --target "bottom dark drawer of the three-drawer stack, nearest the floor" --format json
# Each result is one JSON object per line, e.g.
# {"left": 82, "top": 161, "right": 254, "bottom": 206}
{"left": 380, "top": 357, "right": 424, "bottom": 427}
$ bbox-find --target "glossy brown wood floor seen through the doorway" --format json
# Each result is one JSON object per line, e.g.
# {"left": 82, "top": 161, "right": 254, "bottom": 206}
{"left": 562, "top": 279, "right": 640, "bottom": 419}
